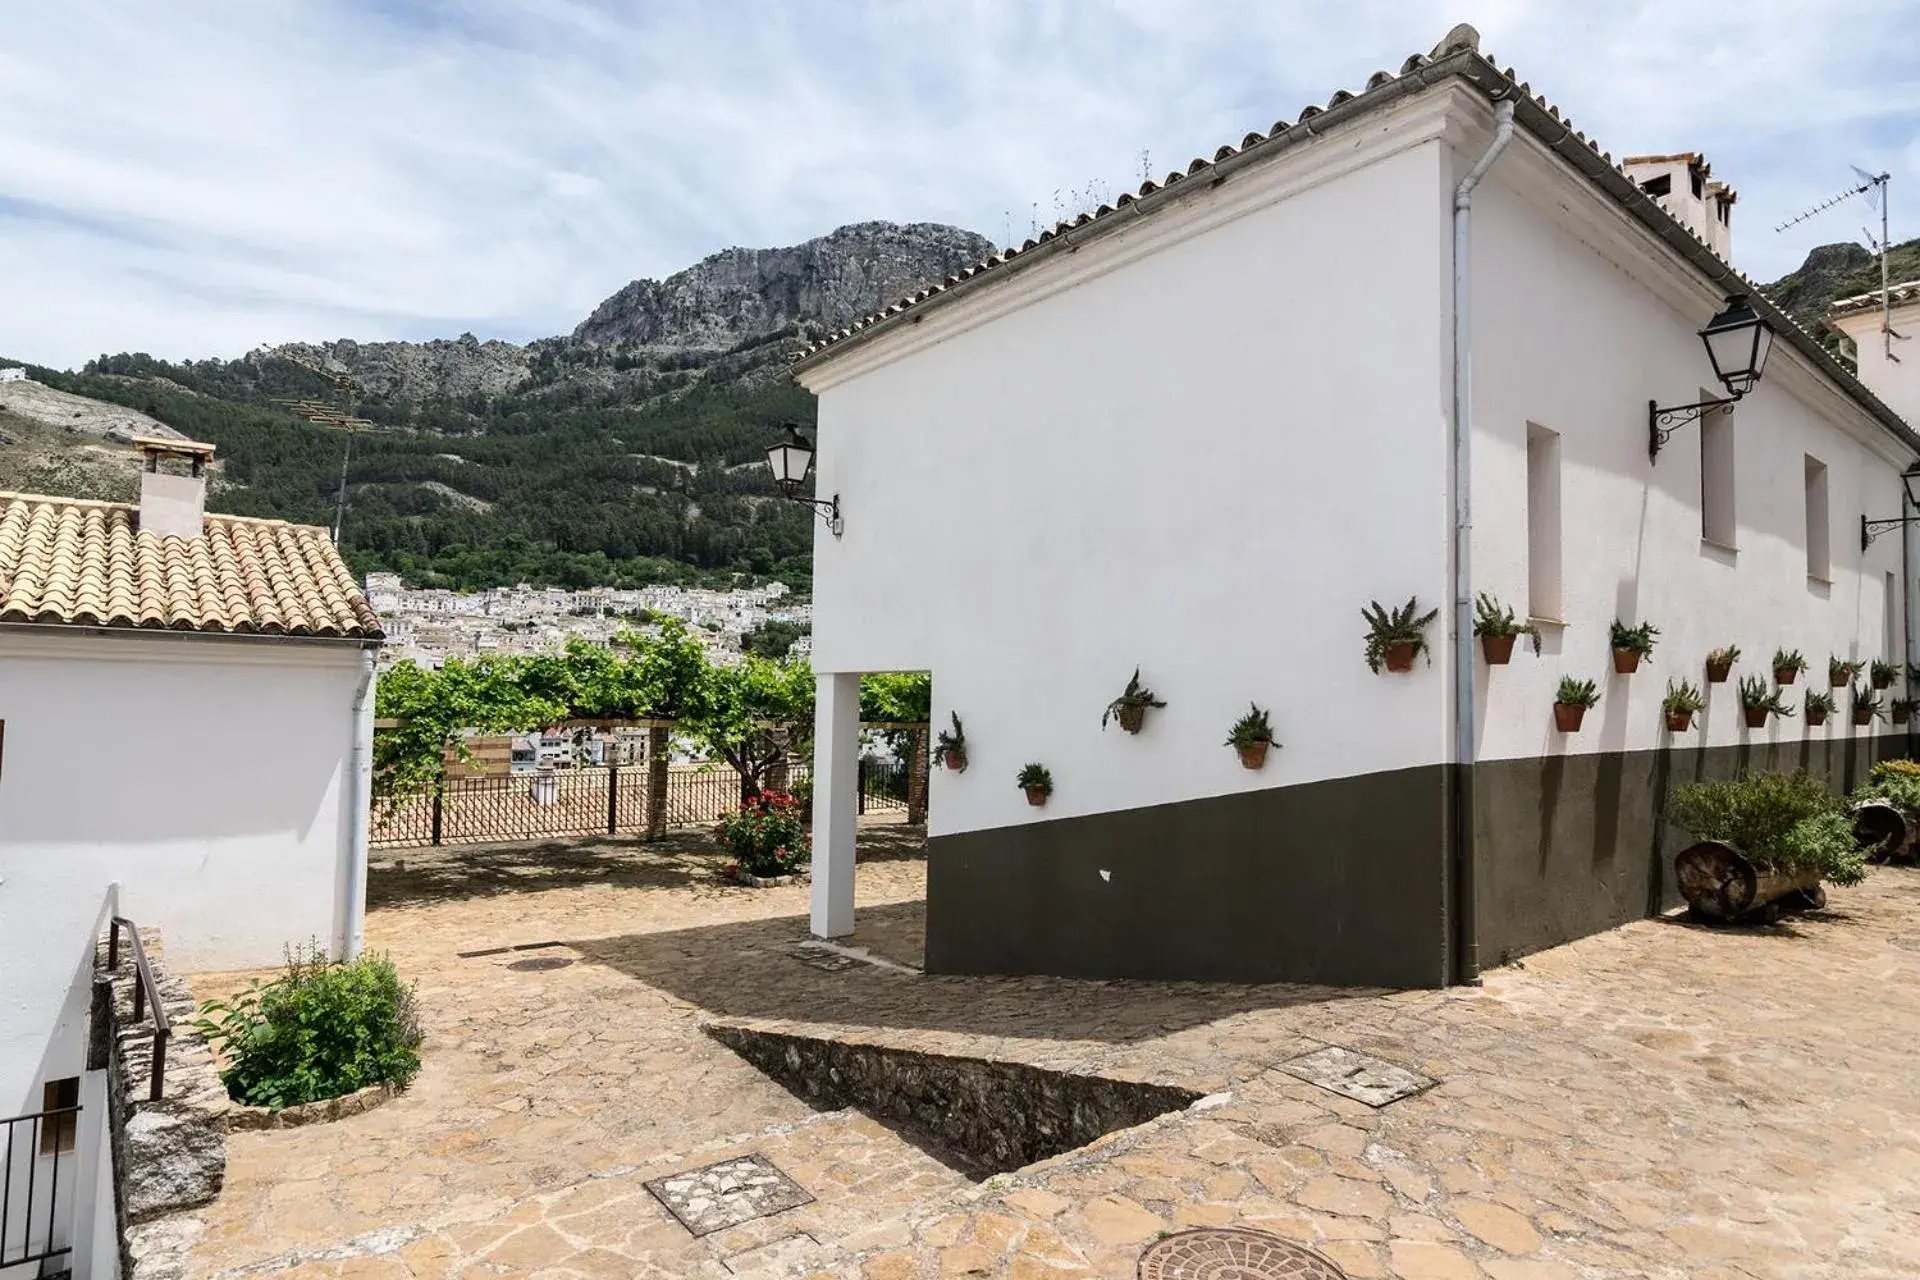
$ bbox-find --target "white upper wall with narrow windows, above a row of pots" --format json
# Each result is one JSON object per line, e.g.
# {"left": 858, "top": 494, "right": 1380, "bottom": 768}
{"left": 1473, "top": 134, "right": 1907, "bottom": 758}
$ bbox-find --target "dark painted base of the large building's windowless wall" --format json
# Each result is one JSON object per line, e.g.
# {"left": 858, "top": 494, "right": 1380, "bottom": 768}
{"left": 925, "top": 766, "right": 1446, "bottom": 986}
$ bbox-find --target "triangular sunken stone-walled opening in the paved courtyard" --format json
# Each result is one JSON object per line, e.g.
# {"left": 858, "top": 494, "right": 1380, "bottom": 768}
{"left": 707, "top": 1023, "right": 1202, "bottom": 1180}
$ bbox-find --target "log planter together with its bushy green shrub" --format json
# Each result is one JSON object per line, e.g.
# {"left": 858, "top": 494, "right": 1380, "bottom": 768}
{"left": 1667, "top": 773, "right": 1866, "bottom": 921}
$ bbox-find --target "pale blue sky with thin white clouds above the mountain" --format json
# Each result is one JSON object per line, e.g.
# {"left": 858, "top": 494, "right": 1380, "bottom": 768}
{"left": 0, "top": 0, "right": 1920, "bottom": 367}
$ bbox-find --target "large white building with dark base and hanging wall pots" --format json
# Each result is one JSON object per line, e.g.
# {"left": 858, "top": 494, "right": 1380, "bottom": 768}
{"left": 797, "top": 27, "right": 1920, "bottom": 984}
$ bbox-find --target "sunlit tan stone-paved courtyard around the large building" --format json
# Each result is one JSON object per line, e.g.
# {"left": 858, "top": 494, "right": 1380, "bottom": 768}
{"left": 180, "top": 825, "right": 1920, "bottom": 1280}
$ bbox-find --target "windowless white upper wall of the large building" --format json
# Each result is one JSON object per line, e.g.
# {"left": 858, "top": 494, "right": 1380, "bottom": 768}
{"left": 803, "top": 109, "right": 1448, "bottom": 835}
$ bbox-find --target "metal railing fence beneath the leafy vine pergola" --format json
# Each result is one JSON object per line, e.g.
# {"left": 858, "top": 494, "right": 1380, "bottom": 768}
{"left": 369, "top": 760, "right": 908, "bottom": 848}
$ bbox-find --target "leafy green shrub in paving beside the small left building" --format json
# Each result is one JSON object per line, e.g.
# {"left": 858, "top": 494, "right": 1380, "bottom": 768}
{"left": 194, "top": 944, "right": 420, "bottom": 1111}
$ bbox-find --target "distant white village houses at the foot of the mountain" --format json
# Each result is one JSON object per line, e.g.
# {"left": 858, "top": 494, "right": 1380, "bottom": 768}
{"left": 367, "top": 574, "right": 812, "bottom": 668}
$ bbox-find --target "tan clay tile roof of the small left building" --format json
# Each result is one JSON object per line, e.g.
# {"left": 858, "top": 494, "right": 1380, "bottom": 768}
{"left": 0, "top": 493, "right": 380, "bottom": 639}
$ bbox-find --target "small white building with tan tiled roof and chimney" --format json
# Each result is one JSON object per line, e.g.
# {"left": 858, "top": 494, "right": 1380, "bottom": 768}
{"left": 0, "top": 439, "right": 380, "bottom": 1274}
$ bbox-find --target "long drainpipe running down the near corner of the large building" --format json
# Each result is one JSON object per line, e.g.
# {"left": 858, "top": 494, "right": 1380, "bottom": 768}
{"left": 1450, "top": 96, "right": 1513, "bottom": 984}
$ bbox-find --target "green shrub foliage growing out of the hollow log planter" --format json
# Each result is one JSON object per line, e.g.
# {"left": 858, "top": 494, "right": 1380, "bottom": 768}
{"left": 1667, "top": 773, "right": 1866, "bottom": 885}
